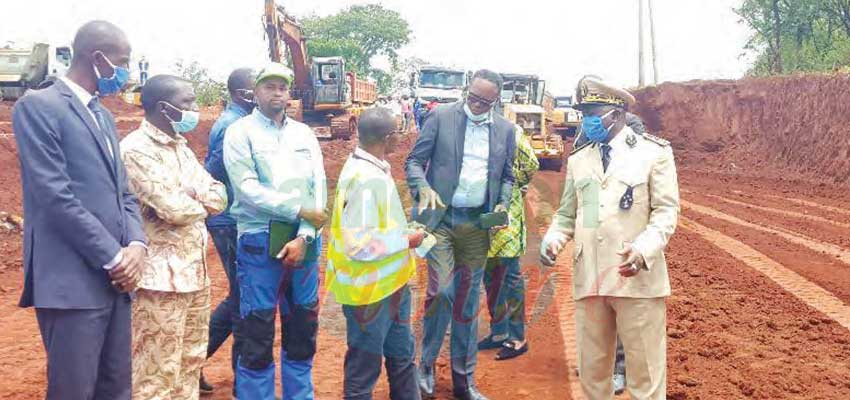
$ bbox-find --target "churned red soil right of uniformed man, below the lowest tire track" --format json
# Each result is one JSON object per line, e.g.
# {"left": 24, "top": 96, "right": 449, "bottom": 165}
{"left": 666, "top": 228, "right": 850, "bottom": 400}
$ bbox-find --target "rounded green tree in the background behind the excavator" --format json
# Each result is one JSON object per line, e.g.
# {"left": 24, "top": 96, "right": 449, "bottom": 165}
{"left": 300, "top": 4, "right": 411, "bottom": 93}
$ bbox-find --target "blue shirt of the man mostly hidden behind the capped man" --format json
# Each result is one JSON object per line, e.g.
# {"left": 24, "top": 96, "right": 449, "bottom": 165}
{"left": 204, "top": 102, "right": 248, "bottom": 226}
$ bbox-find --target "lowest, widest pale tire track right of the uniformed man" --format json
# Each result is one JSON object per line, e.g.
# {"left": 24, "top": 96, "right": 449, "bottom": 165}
{"left": 680, "top": 218, "right": 850, "bottom": 330}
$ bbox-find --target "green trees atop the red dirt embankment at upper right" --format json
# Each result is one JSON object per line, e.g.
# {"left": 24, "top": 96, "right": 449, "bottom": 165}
{"left": 735, "top": 0, "right": 850, "bottom": 75}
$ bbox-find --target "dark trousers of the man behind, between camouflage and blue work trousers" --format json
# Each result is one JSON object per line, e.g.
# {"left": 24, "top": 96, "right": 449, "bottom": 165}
{"left": 207, "top": 225, "right": 241, "bottom": 382}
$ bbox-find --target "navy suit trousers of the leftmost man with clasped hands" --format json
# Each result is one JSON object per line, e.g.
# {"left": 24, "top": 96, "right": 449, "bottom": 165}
{"left": 35, "top": 294, "right": 132, "bottom": 400}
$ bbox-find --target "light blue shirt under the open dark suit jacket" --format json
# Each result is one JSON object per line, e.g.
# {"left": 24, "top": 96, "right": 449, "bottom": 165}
{"left": 451, "top": 117, "right": 493, "bottom": 207}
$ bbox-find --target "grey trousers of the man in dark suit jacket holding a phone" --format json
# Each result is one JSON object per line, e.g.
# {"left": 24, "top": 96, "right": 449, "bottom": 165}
{"left": 422, "top": 207, "right": 490, "bottom": 390}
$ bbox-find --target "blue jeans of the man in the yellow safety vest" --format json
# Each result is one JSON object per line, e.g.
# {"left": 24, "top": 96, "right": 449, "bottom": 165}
{"left": 342, "top": 286, "right": 421, "bottom": 400}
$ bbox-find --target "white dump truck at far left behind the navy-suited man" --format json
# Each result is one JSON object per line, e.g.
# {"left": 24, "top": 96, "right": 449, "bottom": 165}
{"left": 0, "top": 43, "right": 71, "bottom": 100}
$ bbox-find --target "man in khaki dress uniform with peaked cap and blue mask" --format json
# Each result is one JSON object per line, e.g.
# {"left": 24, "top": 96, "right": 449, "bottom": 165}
{"left": 540, "top": 78, "right": 679, "bottom": 400}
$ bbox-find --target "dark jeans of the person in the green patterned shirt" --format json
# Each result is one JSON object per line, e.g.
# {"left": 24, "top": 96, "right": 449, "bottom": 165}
{"left": 484, "top": 257, "right": 525, "bottom": 341}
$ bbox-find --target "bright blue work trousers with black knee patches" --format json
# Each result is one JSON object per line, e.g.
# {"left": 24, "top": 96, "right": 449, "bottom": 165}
{"left": 236, "top": 232, "right": 321, "bottom": 400}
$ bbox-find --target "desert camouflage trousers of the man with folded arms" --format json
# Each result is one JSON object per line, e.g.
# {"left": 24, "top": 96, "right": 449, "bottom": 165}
{"left": 132, "top": 288, "right": 210, "bottom": 400}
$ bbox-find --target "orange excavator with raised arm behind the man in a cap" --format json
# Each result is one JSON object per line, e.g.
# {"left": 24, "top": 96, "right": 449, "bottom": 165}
{"left": 263, "top": 0, "right": 377, "bottom": 140}
